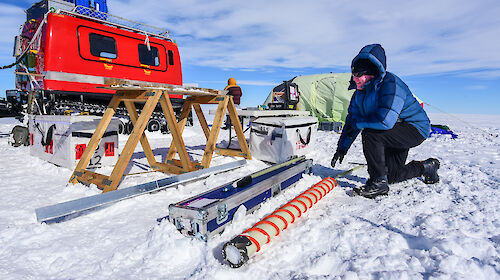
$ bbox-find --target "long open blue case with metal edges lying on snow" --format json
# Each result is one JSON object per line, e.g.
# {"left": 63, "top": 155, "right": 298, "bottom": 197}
{"left": 168, "top": 156, "right": 312, "bottom": 241}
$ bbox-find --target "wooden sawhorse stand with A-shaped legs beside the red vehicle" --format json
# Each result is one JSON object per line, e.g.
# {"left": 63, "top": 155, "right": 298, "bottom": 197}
{"left": 70, "top": 87, "right": 251, "bottom": 192}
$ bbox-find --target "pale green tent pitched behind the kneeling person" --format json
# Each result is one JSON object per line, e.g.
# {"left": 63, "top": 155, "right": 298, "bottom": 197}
{"left": 264, "top": 73, "right": 354, "bottom": 124}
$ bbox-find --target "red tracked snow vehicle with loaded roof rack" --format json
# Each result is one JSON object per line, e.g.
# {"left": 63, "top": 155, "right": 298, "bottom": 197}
{"left": 14, "top": 0, "right": 189, "bottom": 130}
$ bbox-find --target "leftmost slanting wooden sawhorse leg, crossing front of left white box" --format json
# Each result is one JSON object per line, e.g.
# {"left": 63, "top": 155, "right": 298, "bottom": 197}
{"left": 69, "top": 95, "right": 121, "bottom": 184}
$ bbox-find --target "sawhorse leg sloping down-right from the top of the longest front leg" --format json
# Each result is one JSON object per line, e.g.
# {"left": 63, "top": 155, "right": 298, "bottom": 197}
{"left": 160, "top": 94, "right": 191, "bottom": 172}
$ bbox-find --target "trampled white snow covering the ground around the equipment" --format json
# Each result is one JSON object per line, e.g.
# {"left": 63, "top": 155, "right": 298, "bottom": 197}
{"left": 0, "top": 112, "right": 500, "bottom": 280}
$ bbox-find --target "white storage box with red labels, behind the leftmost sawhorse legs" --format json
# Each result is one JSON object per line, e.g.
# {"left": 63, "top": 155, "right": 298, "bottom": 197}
{"left": 29, "top": 115, "right": 119, "bottom": 170}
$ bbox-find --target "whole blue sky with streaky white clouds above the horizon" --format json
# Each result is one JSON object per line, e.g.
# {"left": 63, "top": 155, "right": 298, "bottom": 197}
{"left": 0, "top": 0, "right": 500, "bottom": 114}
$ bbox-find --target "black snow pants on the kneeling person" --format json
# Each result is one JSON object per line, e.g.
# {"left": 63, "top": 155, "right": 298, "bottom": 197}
{"left": 362, "top": 122, "right": 425, "bottom": 184}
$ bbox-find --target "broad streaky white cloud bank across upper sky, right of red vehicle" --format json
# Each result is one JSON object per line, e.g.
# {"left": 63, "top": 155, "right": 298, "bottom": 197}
{"left": 108, "top": 0, "right": 500, "bottom": 74}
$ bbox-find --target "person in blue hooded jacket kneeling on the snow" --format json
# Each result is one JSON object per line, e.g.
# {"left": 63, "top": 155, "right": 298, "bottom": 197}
{"left": 331, "top": 44, "right": 439, "bottom": 198}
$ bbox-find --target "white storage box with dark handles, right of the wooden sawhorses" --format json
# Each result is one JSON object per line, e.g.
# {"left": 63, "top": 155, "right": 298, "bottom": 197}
{"left": 250, "top": 116, "right": 318, "bottom": 163}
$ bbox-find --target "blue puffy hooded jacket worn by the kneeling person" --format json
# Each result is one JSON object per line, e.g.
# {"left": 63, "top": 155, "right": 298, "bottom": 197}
{"left": 338, "top": 44, "right": 431, "bottom": 151}
